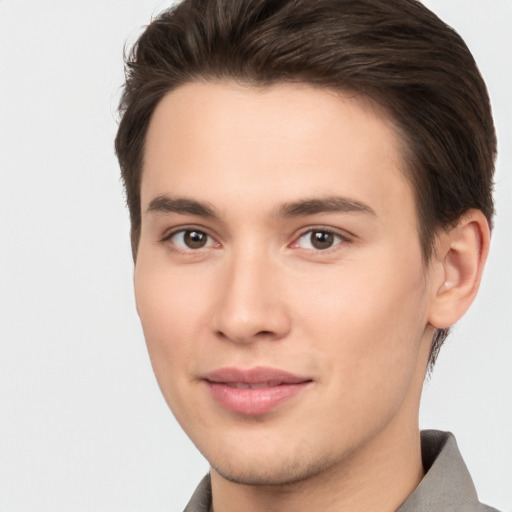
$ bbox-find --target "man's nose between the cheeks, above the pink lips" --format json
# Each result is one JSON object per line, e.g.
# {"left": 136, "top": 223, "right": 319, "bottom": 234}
{"left": 212, "top": 254, "right": 292, "bottom": 344}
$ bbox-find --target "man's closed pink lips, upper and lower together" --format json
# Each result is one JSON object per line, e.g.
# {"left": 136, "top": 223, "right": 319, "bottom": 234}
{"left": 204, "top": 367, "right": 312, "bottom": 416}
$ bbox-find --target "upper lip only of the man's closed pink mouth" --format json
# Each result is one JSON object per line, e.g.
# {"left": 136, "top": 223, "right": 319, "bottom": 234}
{"left": 204, "top": 366, "right": 312, "bottom": 386}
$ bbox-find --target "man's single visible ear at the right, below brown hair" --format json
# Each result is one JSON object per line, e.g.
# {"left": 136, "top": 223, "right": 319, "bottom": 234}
{"left": 429, "top": 210, "right": 490, "bottom": 329}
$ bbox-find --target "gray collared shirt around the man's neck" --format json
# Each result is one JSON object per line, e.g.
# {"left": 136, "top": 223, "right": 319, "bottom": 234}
{"left": 184, "top": 430, "right": 498, "bottom": 512}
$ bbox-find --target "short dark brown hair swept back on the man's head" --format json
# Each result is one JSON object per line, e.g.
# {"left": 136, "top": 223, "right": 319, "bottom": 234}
{"left": 115, "top": 0, "right": 496, "bottom": 364}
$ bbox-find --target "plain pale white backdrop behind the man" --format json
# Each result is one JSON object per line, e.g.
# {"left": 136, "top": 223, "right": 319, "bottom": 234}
{"left": 0, "top": 0, "right": 512, "bottom": 512}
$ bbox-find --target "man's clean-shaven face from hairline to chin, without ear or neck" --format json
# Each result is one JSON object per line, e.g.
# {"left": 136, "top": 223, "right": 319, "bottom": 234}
{"left": 135, "top": 83, "right": 432, "bottom": 484}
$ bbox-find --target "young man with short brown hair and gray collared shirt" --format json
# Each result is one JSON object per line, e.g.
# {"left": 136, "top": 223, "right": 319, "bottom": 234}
{"left": 116, "top": 0, "right": 496, "bottom": 512}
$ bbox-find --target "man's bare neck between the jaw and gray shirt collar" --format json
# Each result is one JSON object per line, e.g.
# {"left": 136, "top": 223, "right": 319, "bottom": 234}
{"left": 211, "top": 416, "right": 424, "bottom": 512}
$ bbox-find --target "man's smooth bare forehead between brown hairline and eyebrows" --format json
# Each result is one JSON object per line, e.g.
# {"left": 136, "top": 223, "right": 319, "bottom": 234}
{"left": 141, "top": 83, "right": 411, "bottom": 221}
